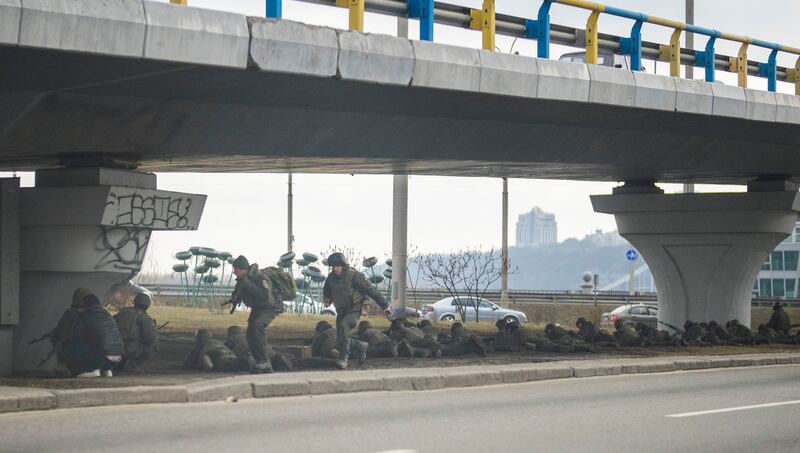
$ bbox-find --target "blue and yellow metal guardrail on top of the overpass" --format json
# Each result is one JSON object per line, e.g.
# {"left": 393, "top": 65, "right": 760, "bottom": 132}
{"left": 170, "top": 0, "right": 800, "bottom": 95}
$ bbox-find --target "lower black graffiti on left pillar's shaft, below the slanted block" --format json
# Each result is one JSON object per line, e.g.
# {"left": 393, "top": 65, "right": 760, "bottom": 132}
{"left": 95, "top": 226, "right": 150, "bottom": 272}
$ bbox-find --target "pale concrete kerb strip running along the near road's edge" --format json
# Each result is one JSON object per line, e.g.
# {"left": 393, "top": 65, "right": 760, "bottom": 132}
{"left": 0, "top": 353, "right": 800, "bottom": 413}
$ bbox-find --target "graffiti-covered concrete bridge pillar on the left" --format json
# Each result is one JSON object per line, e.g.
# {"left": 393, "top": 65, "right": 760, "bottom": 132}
{"left": 6, "top": 167, "right": 206, "bottom": 375}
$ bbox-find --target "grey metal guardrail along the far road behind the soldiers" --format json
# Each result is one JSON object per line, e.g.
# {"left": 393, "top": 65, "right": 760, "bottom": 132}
{"left": 139, "top": 283, "right": 800, "bottom": 307}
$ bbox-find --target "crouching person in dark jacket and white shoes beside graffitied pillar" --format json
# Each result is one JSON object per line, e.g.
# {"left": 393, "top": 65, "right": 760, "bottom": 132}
{"left": 53, "top": 288, "right": 124, "bottom": 377}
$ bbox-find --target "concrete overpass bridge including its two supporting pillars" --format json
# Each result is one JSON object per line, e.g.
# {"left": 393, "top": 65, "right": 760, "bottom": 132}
{"left": 0, "top": 0, "right": 800, "bottom": 373}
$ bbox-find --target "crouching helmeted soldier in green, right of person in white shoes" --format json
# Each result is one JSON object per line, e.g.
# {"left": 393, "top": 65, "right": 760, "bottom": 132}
{"left": 114, "top": 293, "right": 158, "bottom": 371}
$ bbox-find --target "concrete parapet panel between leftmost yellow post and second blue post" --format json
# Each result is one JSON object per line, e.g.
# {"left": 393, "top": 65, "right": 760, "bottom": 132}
{"left": 338, "top": 31, "right": 414, "bottom": 85}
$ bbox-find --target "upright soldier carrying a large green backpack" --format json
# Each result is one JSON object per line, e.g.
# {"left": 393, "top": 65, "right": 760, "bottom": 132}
{"left": 229, "top": 255, "right": 283, "bottom": 373}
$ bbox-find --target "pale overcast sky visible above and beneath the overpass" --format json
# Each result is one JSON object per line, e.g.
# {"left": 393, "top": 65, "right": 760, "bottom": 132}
{"left": 7, "top": 0, "right": 800, "bottom": 268}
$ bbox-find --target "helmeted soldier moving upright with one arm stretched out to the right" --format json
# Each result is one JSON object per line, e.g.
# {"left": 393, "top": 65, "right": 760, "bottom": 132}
{"left": 322, "top": 252, "right": 391, "bottom": 365}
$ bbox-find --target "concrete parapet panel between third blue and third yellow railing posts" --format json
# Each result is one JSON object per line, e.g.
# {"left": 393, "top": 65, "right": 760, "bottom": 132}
{"left": 536, "top": 59, "right": 590, "bottom": 102}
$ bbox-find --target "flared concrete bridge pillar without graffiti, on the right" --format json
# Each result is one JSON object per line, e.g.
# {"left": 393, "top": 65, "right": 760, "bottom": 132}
{"left": 591, "top": 183, "right": 800, "bottom": 328}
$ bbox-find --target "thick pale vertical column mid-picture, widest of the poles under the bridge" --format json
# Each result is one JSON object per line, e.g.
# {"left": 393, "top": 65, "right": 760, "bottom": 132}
{"left": 391, "top": 175, "right": 408, "bottom": 315}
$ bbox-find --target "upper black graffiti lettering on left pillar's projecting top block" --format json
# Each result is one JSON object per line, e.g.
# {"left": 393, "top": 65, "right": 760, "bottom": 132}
{"left": 106, "top": 190, "right": 192, "bottom": 230}
